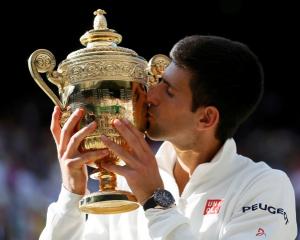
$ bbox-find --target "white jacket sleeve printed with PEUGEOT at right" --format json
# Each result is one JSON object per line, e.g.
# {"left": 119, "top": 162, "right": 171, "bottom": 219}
{"left": 219, "top": 169, "right": 297, "bottom": 240}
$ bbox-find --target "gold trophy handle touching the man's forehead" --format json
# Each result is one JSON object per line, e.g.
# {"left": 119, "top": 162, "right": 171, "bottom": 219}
{"left": 147, "top": 54, "right": 171, "bottom": 87}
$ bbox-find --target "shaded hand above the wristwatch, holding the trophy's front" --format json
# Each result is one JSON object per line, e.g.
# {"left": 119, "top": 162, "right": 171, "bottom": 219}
{"left": 101, "top": 119, "right": 163, "bottom": 203}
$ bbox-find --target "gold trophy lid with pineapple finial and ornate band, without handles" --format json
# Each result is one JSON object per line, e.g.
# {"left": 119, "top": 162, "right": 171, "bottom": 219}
{"left": 57, "top": 9, "right": 147, "bottom": 85}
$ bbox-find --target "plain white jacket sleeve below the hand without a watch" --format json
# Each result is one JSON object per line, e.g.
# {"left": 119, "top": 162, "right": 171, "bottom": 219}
{"left": 39, "top": 186, "right": 85, "bottom": 240}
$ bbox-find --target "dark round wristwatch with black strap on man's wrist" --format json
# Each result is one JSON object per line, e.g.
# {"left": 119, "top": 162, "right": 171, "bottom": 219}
{"left": 143, "top": 188, "right": 175, "bottom": 211}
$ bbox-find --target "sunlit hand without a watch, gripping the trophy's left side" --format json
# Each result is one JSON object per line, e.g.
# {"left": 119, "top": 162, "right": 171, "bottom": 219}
{"left": 51, "top": 106, "right": 108, "bottom": 195}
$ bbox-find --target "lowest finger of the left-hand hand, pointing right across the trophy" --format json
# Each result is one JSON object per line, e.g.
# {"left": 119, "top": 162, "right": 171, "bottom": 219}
{"left": 65, "top": 149, "right": 109, "bottom": 168}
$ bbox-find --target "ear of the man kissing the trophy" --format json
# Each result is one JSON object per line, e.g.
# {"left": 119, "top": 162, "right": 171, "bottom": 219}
{"left": 197, "top": 106, "right": 220, "bottom": 130}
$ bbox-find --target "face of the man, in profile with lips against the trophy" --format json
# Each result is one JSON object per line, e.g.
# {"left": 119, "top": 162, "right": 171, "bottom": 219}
{"left": 147, "top": 63, "right": 196, "bottom": 143}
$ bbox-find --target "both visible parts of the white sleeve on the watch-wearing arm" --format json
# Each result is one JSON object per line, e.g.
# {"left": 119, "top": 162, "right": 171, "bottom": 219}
{"left": 145, "top": 170, "right": 297, "bottom": 240}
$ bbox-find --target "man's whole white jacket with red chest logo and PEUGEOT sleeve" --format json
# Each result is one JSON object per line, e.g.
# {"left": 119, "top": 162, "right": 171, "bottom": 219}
{"left": 40, "top": 139, "right": 297, "bottom": 240}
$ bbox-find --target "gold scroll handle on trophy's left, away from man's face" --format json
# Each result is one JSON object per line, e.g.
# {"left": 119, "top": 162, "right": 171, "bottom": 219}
{"left": 28, "top": 49, "right": 65, "bottom": 110}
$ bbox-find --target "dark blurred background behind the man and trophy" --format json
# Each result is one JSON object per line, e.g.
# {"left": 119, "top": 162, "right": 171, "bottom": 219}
{"left": 0, "top": 0, "right": 300, "bottom": 240}
